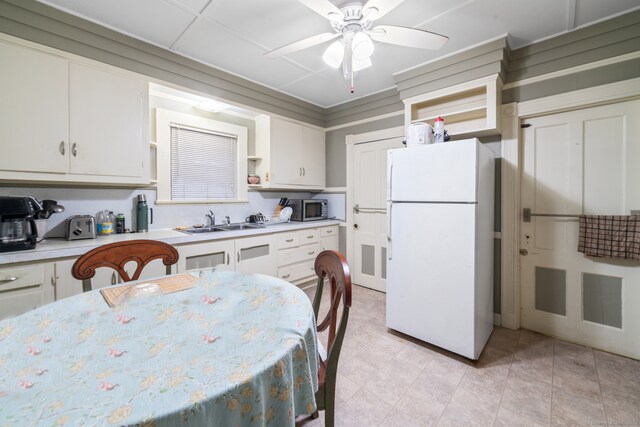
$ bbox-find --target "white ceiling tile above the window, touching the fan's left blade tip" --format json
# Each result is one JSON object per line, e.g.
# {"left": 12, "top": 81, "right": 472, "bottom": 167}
{"left": 174, "top": 18, "right": 307, "bottom": 88}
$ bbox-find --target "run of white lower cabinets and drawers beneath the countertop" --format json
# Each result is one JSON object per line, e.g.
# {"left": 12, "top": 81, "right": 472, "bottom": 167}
{"left": 0, "top": 222, "right": 338, "bottom": 319}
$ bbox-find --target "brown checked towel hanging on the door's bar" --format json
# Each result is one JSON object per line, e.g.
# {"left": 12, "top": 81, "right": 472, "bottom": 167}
{"left": 578, "top": 215, "right": 640, "bottom": 261}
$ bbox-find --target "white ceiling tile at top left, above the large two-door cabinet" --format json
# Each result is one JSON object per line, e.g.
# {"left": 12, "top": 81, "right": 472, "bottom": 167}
{"left": 41, "top": 0, "right": 194, "bottom": 47}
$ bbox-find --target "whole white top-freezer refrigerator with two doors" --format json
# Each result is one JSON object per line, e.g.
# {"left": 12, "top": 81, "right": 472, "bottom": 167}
{"left": 387, "top": 139, "right": 494, "bottom": 360}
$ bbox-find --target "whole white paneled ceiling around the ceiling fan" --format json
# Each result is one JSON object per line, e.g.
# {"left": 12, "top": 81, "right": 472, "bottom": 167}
{"left": 40, "top": 0, "right": 640, "bottom": 107}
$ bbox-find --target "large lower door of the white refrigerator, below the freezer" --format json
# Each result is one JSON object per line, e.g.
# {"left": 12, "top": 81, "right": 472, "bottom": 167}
{"left": 387, "top": 203, "right": 476, "bottom": 359}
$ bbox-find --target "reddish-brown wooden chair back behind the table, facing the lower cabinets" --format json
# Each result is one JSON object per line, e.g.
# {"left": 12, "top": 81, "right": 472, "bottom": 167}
{"left": 71, "top": 240, "right": 178, "bottom": 292}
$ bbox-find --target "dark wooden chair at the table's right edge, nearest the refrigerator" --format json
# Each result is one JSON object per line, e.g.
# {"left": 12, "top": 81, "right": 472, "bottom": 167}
{"left": 312, "top": 251, "right": 351, "bottom": 427}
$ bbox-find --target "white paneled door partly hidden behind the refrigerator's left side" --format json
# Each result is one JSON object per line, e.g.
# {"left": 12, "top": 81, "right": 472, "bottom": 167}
{"left": 351, "top": 138, "right": 402, "bottom": 292}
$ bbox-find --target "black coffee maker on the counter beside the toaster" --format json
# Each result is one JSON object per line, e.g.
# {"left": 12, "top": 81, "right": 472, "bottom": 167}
{"left": 0, "top": 196, "right": 42, "bottom": 252}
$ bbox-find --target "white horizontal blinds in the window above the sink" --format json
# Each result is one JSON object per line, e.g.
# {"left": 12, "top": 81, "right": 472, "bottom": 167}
{"left": 171, "top": 124, "right": 238, "bottom": 200}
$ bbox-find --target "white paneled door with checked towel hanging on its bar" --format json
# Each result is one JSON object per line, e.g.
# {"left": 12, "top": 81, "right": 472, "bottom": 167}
{"left": 520, "top": 101, "right": 640, "bottom": 359}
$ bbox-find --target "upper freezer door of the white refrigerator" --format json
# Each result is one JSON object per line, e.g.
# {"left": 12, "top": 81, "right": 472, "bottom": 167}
{"left": 387, "top": 139, "right": 479, "bottom": 202}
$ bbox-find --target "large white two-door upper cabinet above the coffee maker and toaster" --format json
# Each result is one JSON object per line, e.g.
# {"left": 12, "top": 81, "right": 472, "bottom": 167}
{"left": 0, "top": 40, "right": 150, "bottom": 185}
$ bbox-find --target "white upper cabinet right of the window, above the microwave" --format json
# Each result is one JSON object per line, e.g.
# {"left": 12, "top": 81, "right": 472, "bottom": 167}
{"left": 256, "top": 115, "right": 325, "bottom": 190}
